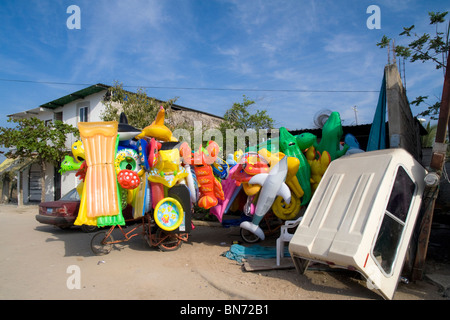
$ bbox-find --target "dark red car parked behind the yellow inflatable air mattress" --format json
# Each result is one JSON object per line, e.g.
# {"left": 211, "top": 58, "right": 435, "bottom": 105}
{"left": 36, "top": 189, "right": 133, "bottom": 232}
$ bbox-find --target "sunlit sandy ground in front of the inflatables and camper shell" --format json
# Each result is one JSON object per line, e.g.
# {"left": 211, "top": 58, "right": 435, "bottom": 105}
{"left": 0, "top": 205, "right": 446, "bottom": 300}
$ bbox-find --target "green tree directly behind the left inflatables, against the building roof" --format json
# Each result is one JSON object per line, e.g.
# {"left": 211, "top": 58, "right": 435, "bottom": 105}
{"left": 101, "top": 82, "right": 177, "bottom": 130}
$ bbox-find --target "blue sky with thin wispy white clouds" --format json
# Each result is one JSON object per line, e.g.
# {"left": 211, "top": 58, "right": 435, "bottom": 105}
{"left": 0, "top": 0, "right": 450, "bottom": 129}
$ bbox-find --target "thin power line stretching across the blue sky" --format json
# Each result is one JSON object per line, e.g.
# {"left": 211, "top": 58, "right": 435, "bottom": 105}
{"left": 0, "top": 78, "right": 379, "bottom": 93}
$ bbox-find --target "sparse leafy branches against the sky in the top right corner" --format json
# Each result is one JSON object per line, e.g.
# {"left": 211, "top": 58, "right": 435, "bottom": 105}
{"left": 377, "top": 11, "right": 450, "bottom": 120}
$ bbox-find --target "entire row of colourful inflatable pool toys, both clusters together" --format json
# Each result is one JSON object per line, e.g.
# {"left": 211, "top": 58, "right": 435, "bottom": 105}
{"left": 61, "top": 107, "right": 353, "bottom": 239}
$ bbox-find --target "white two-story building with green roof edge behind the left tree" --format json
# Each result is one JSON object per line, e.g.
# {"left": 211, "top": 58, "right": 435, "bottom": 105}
{"left": 3, "top": 84, "right": 222, "bottom": 204}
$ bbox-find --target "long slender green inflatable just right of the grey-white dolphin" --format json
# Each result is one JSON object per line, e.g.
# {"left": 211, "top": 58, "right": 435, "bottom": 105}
{"left": 279, "top": 127, "right": 311, "bottom": 205}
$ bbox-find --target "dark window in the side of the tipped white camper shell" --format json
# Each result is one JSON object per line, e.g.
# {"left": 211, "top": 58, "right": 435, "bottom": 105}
{"left": 372, "top": 167, "right": 416, "bottom": 275}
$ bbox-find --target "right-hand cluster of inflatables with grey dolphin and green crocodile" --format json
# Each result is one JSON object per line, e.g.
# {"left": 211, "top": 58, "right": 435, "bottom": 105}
{"left": 211, "top": 112, "right": 362, "bottom": 239}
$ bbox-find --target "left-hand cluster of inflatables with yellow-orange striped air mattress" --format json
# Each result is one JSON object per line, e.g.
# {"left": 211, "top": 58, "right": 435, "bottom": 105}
{"left": 61, "top": 107, "right": 224, "bottom": 231}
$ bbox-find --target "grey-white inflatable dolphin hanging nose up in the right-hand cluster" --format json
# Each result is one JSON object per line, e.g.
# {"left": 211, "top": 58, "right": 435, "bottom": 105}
{"left": 240, "top": 157, "right": 291, "bottom": 240}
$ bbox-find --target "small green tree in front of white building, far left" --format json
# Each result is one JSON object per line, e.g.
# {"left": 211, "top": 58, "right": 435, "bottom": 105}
{"left": 0, "top": 118, "right": 79, "bottom": 201}
